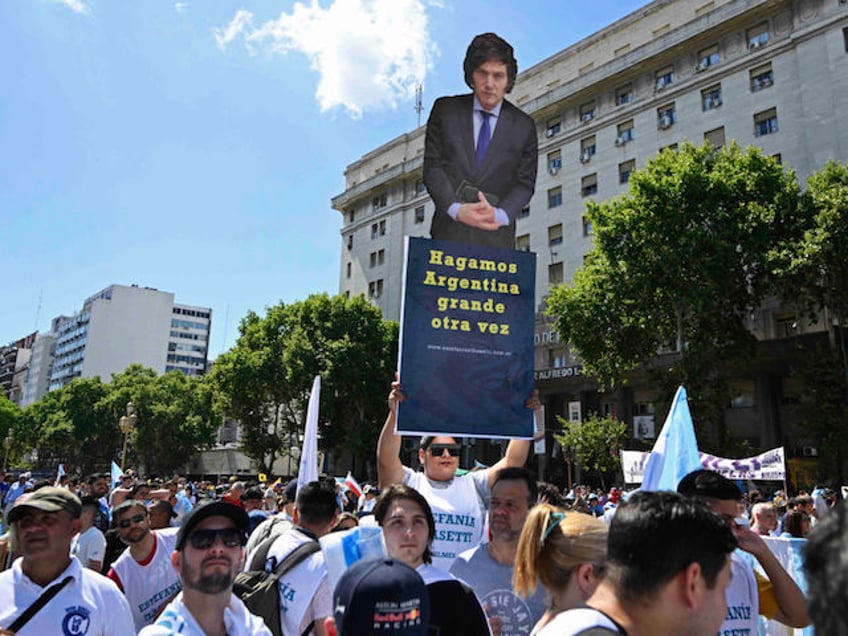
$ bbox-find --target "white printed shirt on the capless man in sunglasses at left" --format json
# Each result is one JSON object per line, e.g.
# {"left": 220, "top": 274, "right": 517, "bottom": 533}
{"left": 110, "top": 528, "right": 182, "bottom": 631}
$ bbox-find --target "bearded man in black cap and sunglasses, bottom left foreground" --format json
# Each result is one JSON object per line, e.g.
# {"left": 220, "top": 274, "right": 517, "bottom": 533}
{"left": 139, "top": 501, "right": 271, "bottom": 636}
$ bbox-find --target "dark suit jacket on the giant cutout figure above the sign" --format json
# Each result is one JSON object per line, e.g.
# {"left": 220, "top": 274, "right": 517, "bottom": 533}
{"left": 424, "top": 94, "right": 539, "bottom": 250}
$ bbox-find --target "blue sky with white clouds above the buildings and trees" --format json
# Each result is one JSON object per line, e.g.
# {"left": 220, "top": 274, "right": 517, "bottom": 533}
{"left": 0, "top": 0, "right": 647, "bottom": 359}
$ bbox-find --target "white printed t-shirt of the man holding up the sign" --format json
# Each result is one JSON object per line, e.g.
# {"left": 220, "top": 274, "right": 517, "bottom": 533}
{"left": 403, "top": 466, "right": 491, "bottom": 570}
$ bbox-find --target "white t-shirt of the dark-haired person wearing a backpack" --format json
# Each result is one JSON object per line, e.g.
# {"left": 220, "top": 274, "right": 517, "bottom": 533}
{"left": 265, "top": 527, "right": 333, "bottom": 634}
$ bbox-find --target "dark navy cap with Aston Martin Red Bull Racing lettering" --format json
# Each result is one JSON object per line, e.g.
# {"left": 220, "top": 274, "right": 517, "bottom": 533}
{"left": 333, "top": 558, "right": 430, "bottom": 636}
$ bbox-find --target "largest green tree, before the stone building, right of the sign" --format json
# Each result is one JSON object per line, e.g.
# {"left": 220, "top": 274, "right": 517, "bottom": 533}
{"left": 548, "top": 143, "right": 805, "bottom": 450}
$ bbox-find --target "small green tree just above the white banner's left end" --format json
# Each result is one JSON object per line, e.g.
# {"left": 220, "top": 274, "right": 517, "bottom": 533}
{"left": 554, "top": 414, "right": 627, "bottom": 486}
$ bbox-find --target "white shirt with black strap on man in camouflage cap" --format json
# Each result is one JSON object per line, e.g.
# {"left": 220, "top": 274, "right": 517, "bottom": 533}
{"left": 0, "top": 557, "right": 135, "bottom": 636}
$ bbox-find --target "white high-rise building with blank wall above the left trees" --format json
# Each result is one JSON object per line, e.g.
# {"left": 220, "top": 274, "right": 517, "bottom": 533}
{"left": 48, "top": 285, "right": 212, "bottom": 391}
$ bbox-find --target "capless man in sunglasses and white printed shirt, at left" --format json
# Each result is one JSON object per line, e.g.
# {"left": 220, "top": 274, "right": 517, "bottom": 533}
{"left": 106, "top": 499, "right": 182, "bottom": 631}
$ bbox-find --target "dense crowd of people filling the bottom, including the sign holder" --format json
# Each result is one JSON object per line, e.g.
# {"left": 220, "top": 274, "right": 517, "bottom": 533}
{"left": 0, "top": 384, "right": 848, "bottom": 636}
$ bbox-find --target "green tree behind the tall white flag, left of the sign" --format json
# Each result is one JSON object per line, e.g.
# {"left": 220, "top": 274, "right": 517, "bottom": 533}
{"left": 210, "top": 294, "right": 397, "bottom": 472}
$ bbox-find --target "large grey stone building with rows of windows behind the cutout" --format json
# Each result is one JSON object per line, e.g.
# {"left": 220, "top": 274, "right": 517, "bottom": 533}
{"left": 332, "top": 0, "right": 848, "bottom": 472}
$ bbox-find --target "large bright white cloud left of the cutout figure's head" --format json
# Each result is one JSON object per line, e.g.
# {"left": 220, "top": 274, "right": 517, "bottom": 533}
{"left": 214, "top": 0, "right": 441, "bottom": 117}
